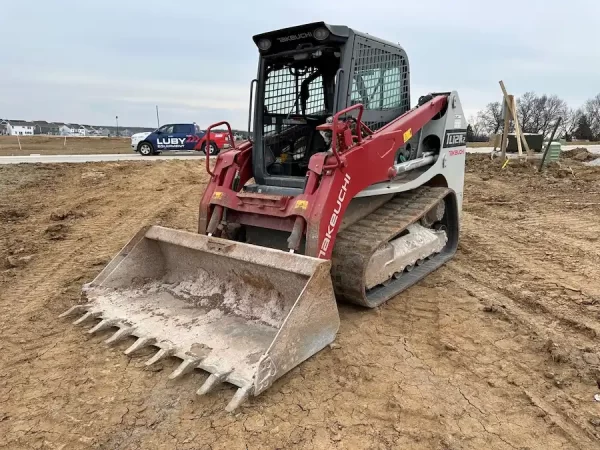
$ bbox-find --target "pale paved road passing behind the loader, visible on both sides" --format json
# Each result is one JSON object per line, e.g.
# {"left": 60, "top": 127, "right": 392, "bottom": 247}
{"left": 0, "top": 145, "right": 600, "bottom": 165}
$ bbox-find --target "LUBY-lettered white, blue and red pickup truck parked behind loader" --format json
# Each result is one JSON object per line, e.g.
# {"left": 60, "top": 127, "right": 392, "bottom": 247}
{"left": 131, "top": 123, "right": 231, "bottom": 156}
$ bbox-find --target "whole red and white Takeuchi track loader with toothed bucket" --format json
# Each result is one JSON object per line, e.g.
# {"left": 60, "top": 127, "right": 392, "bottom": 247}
{"left": 63, "top": 22, "right": 466, "bottom": 411}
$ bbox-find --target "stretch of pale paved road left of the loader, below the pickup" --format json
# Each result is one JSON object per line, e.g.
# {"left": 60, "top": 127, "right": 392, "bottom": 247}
{"left": 0, "top": 153, "right": 204, "bottom": 164}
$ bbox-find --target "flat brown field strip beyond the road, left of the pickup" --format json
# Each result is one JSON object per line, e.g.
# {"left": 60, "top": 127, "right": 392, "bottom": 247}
{"left": 0, "top": 136, "right": 133, "bottom": 156}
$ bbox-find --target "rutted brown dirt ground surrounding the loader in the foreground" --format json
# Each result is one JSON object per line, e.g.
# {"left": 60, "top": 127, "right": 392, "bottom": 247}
{"left": 0, "top": 155, "right": 600, "bottom": 450}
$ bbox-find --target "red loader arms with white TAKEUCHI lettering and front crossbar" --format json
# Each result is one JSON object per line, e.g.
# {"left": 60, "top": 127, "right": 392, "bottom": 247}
{"left": 198, "top": 94, "right": 448, "bottom": 259}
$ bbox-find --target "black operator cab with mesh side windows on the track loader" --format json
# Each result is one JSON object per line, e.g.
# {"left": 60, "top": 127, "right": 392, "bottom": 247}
{"left": 245, "top": 22, "right": 410, "bottom": 195}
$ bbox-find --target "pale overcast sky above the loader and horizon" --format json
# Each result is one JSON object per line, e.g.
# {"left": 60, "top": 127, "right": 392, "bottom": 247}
{"left": 0, "top": 0, "right": 600, "bottom": 128}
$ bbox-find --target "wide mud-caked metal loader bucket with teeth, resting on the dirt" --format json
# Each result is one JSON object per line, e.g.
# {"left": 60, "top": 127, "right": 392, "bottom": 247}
{"left": 63, "top": 226, "right": 339, "bottom": 411}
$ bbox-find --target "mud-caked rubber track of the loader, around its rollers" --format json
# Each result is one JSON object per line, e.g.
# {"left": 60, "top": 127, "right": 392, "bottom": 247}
{"left": 331, "top": 186, "right": 452, "bottom": 307}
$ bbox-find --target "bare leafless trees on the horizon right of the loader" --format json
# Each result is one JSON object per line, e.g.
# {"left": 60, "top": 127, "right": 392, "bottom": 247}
{"left": 467, "top": 92, "right": 600, "bottom": 141}
